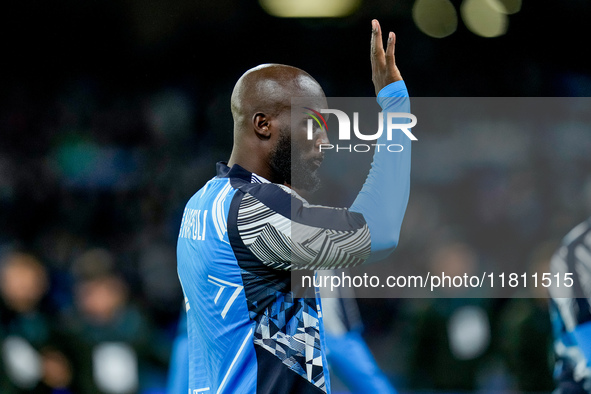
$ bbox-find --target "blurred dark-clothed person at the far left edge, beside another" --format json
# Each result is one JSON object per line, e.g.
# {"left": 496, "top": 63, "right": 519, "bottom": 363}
{"left": 0, "top": 253, "right": 73, "bottom": 394}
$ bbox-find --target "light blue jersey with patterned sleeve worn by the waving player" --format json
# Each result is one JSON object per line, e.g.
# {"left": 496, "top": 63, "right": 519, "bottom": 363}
{"left": 177, "top": 81, "right": 410, "bottom": 394}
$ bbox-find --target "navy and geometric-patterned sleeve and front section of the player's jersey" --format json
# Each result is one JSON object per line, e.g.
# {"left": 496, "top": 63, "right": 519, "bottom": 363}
{"left": 220, "top": 165, "right": 371, "bottom": 393}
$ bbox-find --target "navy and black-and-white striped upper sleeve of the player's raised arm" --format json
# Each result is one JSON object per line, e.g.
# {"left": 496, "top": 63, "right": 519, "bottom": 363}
{"left": 232, "top": 183, "right": 371, "bottom": 270}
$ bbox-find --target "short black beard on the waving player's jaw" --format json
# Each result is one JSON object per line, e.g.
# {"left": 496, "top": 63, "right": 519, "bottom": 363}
{"left": 271, "top": 132, "right": 320, "bottom": 193}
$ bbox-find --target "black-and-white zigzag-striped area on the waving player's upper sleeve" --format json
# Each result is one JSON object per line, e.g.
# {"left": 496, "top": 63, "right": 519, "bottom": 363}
{"left": 238, "top": 193, "right": 371, "bottom": 270}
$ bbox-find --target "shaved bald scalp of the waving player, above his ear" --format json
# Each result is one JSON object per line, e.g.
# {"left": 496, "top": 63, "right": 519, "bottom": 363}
{"left": 231, "top": 64, "right": 324, "bottom": 133}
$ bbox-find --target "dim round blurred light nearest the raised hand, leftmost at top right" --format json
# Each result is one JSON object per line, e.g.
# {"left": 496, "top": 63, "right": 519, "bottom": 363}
{"left": 412, "top": 0, "right": 458, "bottom": 38}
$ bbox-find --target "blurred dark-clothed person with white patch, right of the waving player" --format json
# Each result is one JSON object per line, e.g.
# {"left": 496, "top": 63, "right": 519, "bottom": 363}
{"left": 406, "top": 242, "right": 491, "bottom": 391}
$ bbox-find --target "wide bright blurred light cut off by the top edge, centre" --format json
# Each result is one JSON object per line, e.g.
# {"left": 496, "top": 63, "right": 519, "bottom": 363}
{"left": 259, "top": 0, "right": 361, "bottom": 18}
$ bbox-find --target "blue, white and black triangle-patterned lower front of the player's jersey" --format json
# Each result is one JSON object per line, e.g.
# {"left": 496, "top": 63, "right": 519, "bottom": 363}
{"left": 254, "top": 293, "right": 326, "bottom": 392}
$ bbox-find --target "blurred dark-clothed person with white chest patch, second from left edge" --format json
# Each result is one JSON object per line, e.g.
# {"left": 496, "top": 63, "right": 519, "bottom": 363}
{"left": 58, "top": 249, "right": 170, "bottom": 394}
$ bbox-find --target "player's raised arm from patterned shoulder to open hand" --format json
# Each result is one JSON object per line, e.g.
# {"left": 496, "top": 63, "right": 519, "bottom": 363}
{"left": 234, "top": 20, "right": 410, "bottom": 270}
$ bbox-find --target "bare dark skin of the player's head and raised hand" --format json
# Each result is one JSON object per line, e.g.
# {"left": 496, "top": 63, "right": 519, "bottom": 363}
{"left": 228, "top": 19, "right": 402, "bottom": 184}
